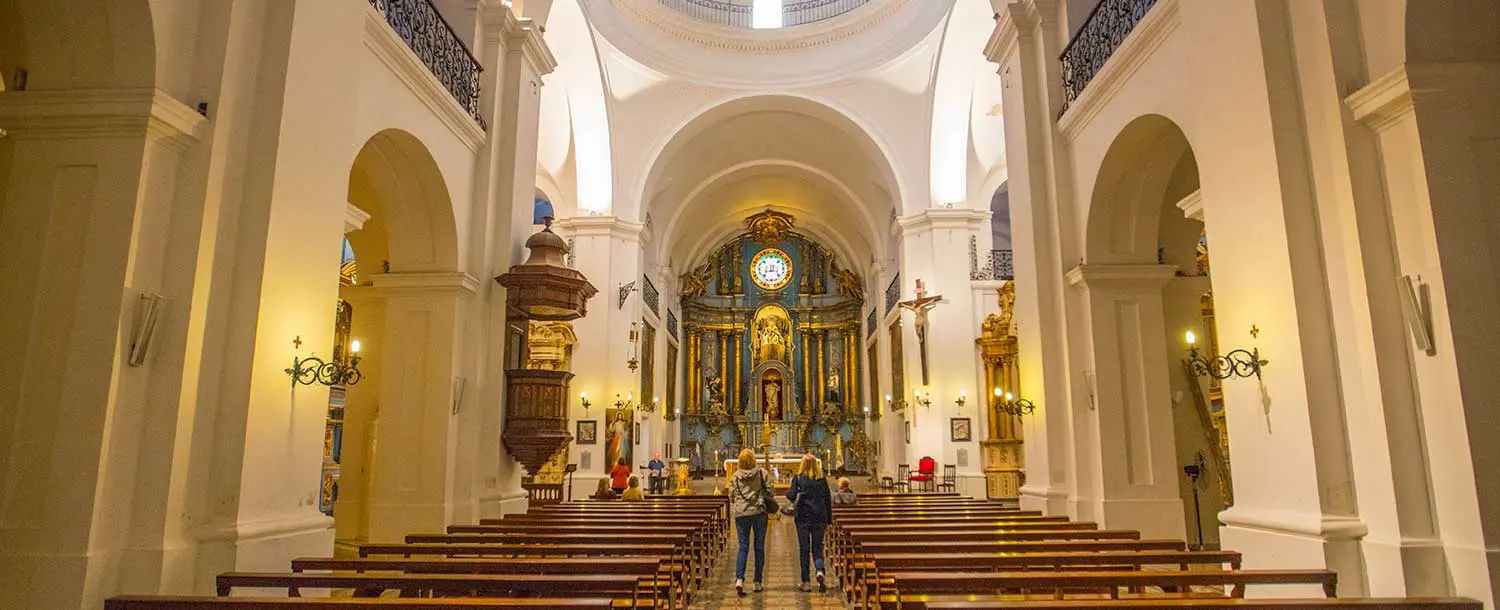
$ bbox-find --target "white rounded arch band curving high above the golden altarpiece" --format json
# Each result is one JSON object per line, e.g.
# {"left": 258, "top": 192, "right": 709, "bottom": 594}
{"left": 621, "top": 93, "right": 908, "bottom": 219}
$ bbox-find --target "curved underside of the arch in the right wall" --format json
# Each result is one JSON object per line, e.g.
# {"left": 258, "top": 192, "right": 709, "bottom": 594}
{"left": 1085, "top": 114, "right": 1199, "bottom": 264}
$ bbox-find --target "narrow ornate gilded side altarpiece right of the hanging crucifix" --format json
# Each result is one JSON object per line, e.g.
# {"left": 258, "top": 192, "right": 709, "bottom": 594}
{"left": 974, "top": 282, "right": 1023, "bottom": 499}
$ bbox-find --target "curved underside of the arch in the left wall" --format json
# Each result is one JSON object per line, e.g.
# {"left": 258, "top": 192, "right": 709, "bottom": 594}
{"left": 348, "top": 129, "right": 459, "bottom": 271}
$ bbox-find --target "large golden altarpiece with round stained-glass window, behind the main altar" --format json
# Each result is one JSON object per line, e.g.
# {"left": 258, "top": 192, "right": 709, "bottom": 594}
{"left": 680, "top": 210, "right": 869, "bottom": 472}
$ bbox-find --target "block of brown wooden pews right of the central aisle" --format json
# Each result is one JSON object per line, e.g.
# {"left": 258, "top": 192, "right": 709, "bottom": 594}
{"left": 827, "top": 495, "right": 1482, "bottom": 610}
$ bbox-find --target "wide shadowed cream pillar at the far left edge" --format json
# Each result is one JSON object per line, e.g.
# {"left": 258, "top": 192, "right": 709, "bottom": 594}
{"left": 0, "top": 90, "right": 206, "bottom": 607}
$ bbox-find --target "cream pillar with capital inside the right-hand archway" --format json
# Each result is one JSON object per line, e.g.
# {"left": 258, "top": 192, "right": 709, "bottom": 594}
{"left": 1068, "top": 265, "right": 1184, "bottom": 538}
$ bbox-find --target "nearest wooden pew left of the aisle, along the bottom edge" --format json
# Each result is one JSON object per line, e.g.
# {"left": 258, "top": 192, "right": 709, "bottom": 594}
{"left": 104, "top": 595, "right": 630, "bottom": 610}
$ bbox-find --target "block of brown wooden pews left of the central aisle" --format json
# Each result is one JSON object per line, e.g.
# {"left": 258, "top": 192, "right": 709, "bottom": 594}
{"left": 105, "top": 496, "right": 729, "bottom": 610}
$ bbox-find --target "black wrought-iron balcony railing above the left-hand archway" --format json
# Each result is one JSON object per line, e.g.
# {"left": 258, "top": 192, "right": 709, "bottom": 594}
{"left": 369, "top": 0, "right": 489, "bottom": 129}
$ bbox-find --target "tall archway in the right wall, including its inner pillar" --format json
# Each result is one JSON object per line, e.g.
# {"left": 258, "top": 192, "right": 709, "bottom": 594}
{"left": 1070, "top": 115, "right": 1233, "bottom": 547}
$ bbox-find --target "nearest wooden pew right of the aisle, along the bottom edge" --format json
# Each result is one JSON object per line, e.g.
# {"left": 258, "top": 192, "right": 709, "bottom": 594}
{"left": 926, "top": 598, "right": 1484, "bottom": 610}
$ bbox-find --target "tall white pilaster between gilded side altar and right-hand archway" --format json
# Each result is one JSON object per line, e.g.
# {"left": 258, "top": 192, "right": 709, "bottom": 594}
{"left": 986, "top": 0, "right": 1074, "bottom": 514}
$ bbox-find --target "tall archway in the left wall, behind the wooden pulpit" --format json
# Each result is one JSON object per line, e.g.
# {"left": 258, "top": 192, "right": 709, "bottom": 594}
{"left": 334, "top": 129, "right": 462, "bottom": 546}
